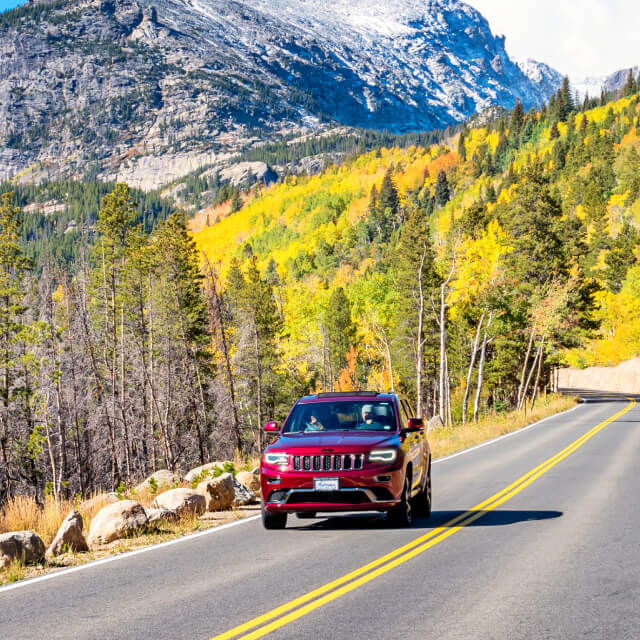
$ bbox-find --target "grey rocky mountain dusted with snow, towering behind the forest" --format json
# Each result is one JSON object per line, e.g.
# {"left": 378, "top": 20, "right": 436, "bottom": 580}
{"left": 0, "top": 0, "right": 559, "bottom": 188}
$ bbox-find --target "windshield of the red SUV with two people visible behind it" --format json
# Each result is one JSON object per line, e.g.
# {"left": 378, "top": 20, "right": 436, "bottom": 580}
{"left": 283, "top": 400, "right": 396, "bottom": 433}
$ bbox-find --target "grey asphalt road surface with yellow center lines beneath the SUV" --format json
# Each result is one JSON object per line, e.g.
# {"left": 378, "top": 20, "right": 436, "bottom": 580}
{"left": 0, "top": 395, "right": 640, "bottom": 640}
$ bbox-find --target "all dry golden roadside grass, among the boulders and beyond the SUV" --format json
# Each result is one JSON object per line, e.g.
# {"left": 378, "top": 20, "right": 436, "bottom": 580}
{"left": 0, "top": 395, "right": 576, "bottom": 584}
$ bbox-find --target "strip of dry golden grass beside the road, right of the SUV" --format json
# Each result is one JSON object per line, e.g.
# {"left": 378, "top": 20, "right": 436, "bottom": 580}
{"left": 429, "top": 395, "right": 577, "bottom": 458}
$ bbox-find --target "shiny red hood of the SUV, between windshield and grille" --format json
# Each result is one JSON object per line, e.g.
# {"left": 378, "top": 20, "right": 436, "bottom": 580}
{"left": 269, "top": 431, "right": 400, "bottom": 453}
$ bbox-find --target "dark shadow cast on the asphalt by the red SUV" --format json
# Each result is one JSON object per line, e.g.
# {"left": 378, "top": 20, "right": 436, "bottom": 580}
{"left": 289, "top": 509, "right": 563, "bottom": 531}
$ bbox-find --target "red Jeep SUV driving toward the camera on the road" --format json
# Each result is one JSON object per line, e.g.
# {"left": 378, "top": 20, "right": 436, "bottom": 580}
{"left": 260, "top": 391, "right": 431, "bottom": 529}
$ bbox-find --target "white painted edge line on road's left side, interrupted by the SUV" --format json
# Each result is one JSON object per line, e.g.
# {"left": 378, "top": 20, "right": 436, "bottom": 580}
{"left": 0, "top": 404, "right": 581, "bottom": 594}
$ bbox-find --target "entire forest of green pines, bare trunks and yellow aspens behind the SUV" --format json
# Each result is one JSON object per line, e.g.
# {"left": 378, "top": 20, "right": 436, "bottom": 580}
{"left": 0, "top": 75, "right": 640, "bottom": 502}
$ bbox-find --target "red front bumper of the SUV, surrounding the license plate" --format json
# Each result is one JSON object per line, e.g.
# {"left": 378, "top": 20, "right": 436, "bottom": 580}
{"left": 261, "top": 465, "right": 404, "bottom": 513}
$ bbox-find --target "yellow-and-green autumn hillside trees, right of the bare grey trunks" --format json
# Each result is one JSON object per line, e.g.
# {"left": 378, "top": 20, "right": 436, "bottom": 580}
{"left": 195, "top": 77, "right": 640, "bottom": 422}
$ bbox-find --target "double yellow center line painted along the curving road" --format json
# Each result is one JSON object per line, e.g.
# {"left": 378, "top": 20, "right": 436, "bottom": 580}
{"left": 211, "top": 400, "right": 636, "bottom": 640}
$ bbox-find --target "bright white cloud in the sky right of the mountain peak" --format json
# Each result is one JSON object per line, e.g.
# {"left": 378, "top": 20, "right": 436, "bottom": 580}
{"left": 466, "top": 0, "right": 640, "bottom": 78}
